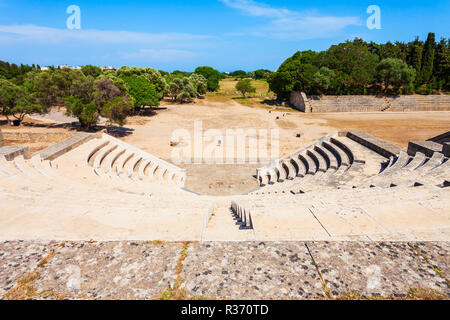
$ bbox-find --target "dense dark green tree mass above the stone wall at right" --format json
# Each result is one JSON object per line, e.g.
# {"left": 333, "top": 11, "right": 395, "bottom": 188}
{"left": 267, "top": 33, "right": 450, "bottom": 100}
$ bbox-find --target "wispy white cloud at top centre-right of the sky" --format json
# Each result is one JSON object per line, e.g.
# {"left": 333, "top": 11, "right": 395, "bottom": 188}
{"left": 219, "top": 0, "right": 362, "bottom": 40}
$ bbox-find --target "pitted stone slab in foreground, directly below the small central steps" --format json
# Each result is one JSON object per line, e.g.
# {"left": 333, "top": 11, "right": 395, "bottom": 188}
{"left": 181, "top": 242, "right": 325, "bottom": 300}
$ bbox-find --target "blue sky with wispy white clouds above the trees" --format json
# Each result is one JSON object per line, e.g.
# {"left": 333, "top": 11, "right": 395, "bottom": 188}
{"left": 0, "top": 0, "right": 450, "bottom": 71}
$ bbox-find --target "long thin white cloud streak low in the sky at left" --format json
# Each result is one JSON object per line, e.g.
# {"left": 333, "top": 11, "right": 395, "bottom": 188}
{"left": 0, "top": 25, "right": 212, "bottom": 45}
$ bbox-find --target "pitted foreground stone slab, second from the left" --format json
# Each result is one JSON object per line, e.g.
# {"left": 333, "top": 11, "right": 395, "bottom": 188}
{"left": 35, "top": 242, "right": 181, "bottom": 299}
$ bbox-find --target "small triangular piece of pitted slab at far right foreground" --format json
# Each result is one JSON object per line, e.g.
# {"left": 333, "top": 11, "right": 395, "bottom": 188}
{"left": 410, "top": 242, "right": 450, "bottom": 280}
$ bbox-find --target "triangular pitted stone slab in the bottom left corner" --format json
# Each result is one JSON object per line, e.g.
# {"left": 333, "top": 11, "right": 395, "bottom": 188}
{"left": 0, "top": 241, "right": 57, "bottom": 295}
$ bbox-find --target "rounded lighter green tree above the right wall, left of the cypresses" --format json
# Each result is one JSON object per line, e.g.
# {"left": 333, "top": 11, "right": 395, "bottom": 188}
{"left": 376, "top": 58, "right": 416, "bottom": 94}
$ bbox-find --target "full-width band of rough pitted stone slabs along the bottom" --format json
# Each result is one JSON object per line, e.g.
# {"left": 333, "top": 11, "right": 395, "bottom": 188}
{"left": 0, "top": 241, "right": 450, "bottom": 300}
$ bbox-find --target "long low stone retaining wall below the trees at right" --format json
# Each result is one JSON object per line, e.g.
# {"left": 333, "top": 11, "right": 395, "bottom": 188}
{"left": 290, "top": 92, "right": 450, "bottom": 112}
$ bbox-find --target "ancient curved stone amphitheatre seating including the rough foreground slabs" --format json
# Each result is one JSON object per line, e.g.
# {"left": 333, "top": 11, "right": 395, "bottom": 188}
{"left": 0, "top": 120, "right": 450, "bottom": 299}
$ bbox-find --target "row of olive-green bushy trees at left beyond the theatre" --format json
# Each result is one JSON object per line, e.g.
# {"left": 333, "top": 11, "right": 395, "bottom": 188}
{"left": 0, "top": 62, "right": 222, "bottom": 129}
